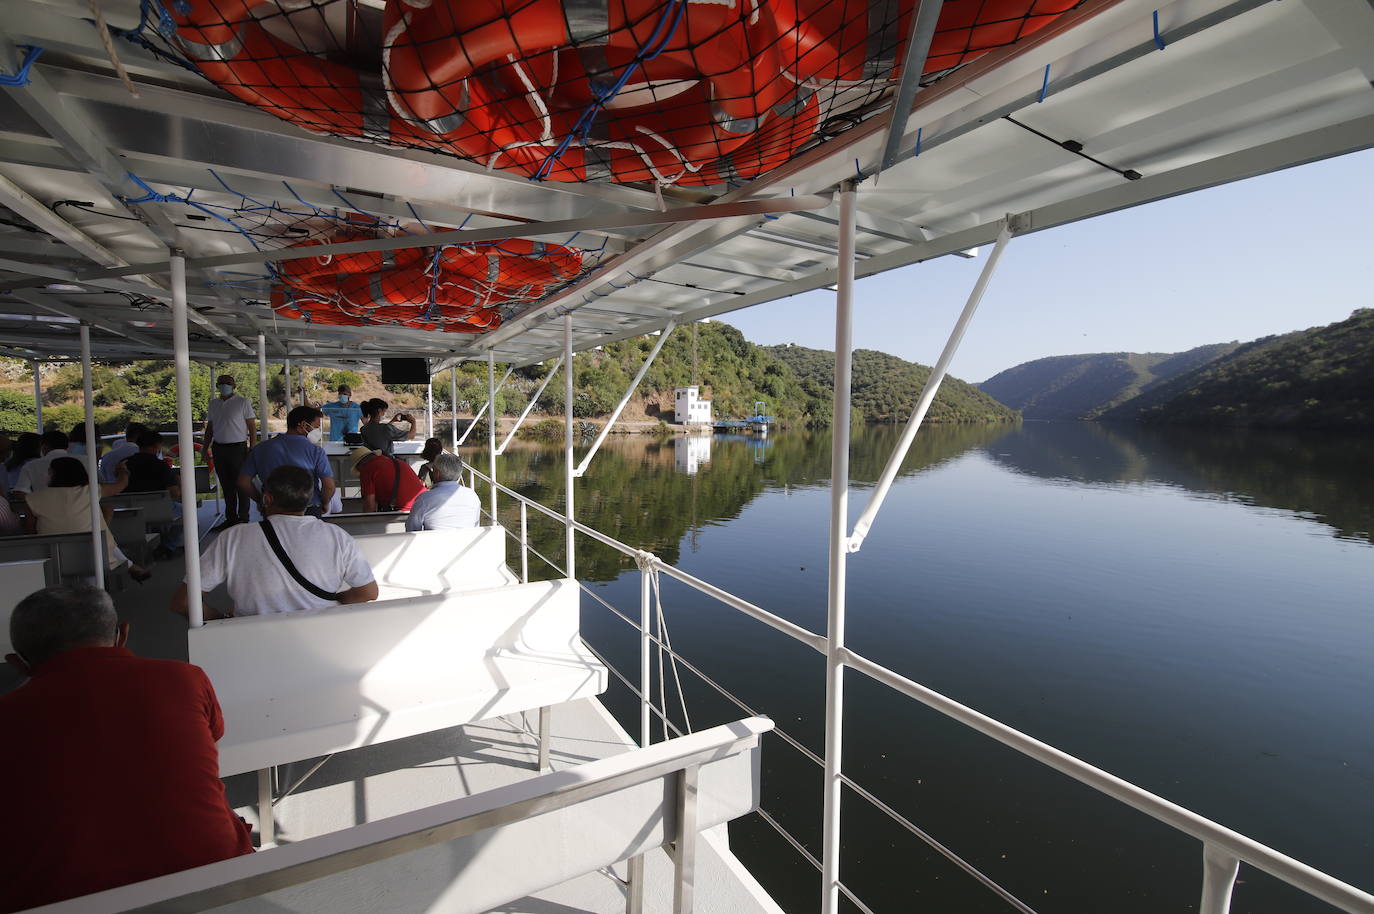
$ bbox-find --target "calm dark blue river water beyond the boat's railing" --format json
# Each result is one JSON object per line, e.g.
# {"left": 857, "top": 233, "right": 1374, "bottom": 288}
{"left": 467, "top": 423, "right": 1374, "bottom": 914}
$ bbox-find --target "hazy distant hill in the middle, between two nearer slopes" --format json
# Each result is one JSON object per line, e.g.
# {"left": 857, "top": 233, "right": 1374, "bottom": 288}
{"left": 978, "top": 342, "right": 1239, "bottom": 419}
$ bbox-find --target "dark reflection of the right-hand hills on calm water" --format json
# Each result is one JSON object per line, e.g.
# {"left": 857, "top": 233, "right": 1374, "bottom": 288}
{"left": 984, "top": 422, "right": 1374, "bottom": 542}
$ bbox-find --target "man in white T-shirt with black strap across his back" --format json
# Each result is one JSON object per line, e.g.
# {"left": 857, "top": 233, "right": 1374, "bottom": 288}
{"left": 172, "top": 466, "right": 376, "bottom": 618}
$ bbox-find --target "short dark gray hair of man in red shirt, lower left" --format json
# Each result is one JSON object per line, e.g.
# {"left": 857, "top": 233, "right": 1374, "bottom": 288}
{"left": 10, "top": 584, "right": 120, "bottom": 667}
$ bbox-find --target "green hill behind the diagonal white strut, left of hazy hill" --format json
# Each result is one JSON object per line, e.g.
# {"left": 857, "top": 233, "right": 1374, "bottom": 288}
{"left": 764, "top": 345, "right": 1018, "bottom": 422}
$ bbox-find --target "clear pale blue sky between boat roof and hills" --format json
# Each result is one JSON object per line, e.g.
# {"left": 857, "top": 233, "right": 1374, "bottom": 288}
{"left": 723, "top": 150, "right": 1374, "bottom": 381}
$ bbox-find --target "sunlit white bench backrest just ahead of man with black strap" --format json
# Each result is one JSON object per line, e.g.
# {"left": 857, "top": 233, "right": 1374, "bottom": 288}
{"left": 354, "top": 526, "right": 513, "bottom": 599}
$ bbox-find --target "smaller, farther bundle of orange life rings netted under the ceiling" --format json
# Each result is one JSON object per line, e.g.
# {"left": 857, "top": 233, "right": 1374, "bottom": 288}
{"left": 272, "top": 235, "right": 583, "bottom": 333}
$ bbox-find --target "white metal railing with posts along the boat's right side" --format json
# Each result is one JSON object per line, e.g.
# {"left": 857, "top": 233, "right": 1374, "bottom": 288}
{"left": 469, "top": 467, "right": 1374, "bottom": 914}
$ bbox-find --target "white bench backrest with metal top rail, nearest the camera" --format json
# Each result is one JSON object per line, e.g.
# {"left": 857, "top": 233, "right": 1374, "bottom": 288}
{"left": 44, "top": 717, "right": 772, "bottom": 914}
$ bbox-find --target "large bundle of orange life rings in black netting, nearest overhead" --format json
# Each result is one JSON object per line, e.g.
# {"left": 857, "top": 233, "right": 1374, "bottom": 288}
{"left": 161, "top": 0, "right": 1081, "bottom": 186}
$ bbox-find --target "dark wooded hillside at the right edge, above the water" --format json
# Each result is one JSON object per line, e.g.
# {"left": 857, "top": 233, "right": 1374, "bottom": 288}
{"left": 1101, "top": 308, "right": 1374, "bottom": 427}
